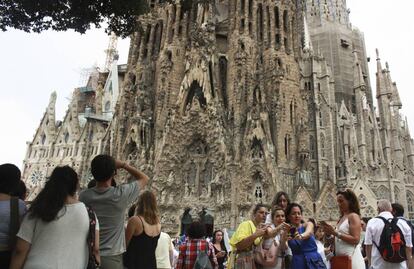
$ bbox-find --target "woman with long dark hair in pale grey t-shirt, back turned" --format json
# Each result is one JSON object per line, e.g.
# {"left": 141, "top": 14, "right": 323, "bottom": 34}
{"left": 10, "top": 166, "right": 99, "bottom": 269}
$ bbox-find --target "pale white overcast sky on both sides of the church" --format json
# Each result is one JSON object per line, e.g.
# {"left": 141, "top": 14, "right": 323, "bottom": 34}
{"left": 0, "top": 0, "right": 414, "bottom": 167}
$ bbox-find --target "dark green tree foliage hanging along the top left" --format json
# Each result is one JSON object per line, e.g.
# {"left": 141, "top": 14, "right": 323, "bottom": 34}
{"left": 0, "top": 0, "right": 212, "bottom": 37}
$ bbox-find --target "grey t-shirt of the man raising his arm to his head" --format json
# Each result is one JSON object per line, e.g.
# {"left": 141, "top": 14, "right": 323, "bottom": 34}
{"left": 79, "top": 181, "right": 139, "bottom": 256}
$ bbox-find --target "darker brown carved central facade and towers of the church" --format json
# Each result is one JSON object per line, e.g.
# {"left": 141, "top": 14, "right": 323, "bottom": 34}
{"left": 107, "top": 0, "right": 312, "bottom": 229}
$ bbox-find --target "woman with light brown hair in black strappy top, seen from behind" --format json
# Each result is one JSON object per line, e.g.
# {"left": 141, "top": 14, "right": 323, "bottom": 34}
{"left": 124, "top": 191, "right": 161, "bottom": 269}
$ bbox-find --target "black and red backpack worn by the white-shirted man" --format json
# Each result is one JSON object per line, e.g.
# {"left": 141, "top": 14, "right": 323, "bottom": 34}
{"left": 374, "top": 217, "right": 407, "bottom": 263}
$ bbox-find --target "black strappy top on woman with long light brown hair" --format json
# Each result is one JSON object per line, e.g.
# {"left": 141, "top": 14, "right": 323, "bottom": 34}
{"left": 123, "top": 217, "right": 160, "bottom": 269}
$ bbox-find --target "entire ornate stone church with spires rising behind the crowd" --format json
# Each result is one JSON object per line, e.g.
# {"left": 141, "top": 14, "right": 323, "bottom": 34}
{"left": 23, "top": 0, "right": 414, "bottom": 233}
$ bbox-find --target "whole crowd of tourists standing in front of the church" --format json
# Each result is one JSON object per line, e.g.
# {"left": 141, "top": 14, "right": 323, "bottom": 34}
{"left": 0, "top": 155, "right": 414, "bottom": 269}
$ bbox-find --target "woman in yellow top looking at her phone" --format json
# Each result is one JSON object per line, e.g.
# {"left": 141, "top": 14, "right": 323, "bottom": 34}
{"left": 228, "top": 204, "right": 267, "bottom": 269}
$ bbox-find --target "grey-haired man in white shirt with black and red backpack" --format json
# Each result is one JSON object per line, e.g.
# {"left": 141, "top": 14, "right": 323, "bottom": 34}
{"left": 365, "top": 200, "right": 414, "bottom": 269}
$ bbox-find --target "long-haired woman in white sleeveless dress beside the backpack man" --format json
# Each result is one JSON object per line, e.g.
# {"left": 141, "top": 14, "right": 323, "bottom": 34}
{"left": 322, "top": 189, "right": 365, "bottom": 269}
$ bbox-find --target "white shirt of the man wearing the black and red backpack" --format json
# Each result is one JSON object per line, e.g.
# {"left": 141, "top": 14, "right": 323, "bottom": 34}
{"left": 365, "top": 212, "right": 413, "bottom": 269}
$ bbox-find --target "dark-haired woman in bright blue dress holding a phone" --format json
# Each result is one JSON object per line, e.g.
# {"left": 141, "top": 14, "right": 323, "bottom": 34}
{"left": 286, "top": 203, "right": 326, "bottom": 269}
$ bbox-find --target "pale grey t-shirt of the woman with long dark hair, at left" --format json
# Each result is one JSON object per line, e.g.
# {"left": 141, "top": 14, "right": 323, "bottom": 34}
{"left": 17, "top": 203, "right": 93, "bottom": 269}
